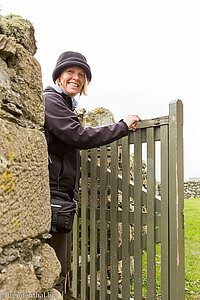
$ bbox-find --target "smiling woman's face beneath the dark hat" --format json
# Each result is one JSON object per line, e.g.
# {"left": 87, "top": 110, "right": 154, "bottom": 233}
{"left": 58, "top": 66, "right": 85, "bottom": 97}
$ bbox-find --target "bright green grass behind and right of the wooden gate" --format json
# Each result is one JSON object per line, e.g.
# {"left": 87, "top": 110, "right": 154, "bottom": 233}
{"left": 132, "top": 198, "right": 200, "bottom": 300}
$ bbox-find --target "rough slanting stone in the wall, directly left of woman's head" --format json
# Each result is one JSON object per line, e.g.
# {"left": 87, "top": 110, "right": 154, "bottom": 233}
{"left": 8, "top": 44, "right": 44, "bottom": 127}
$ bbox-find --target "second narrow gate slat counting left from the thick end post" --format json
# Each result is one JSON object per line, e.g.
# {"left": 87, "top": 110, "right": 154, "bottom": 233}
{"left": 147, "top": 127, "right": 156, "bottom": 300}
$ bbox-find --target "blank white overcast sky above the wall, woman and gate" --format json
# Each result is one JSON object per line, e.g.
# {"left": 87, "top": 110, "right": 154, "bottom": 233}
{"left": 0, "top": 0, "right": 200, "bottom": 179}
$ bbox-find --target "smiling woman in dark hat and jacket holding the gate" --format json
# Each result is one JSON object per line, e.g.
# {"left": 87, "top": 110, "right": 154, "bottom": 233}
{"left": 44, "top": 51, "right": 140, "bottom": 292}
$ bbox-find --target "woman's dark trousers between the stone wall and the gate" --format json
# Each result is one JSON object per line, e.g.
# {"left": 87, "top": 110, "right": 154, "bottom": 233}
{"left": 48, "top": 230, "right": 72, "bottom": 293}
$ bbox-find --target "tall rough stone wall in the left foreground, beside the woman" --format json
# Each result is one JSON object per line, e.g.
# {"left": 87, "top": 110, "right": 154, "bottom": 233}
{"left": 0, "top": 15, "right": 60, "bottom": 299}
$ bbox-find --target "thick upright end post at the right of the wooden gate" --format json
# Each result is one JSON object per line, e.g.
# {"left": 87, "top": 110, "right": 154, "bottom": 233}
{"left": 169, "top": 100, "right": 185, "bottom": 300}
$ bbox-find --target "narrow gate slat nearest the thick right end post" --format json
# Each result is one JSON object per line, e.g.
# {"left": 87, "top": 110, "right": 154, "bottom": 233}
{"left": 160, "top": 126, "right": 169, "bottom": 300}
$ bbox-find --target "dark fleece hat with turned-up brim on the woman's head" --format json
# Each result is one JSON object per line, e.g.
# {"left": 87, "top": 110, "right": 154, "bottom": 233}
{"left": 52, "top": 51, "right": 92, "bottom": 82}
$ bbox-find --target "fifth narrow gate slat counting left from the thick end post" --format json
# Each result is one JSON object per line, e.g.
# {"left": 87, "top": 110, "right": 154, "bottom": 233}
{"left": 110, "top": 142, "right": 119, "bottom": 300}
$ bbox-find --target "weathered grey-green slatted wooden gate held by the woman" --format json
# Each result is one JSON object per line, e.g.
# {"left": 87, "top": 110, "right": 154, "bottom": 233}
{"left": 72, "top": 100, "right": 185, "bottom": 300}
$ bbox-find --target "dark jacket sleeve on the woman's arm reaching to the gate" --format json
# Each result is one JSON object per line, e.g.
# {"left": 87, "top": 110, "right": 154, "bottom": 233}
{"left": 45, "top": 94, "right": 129, "bottom": 149}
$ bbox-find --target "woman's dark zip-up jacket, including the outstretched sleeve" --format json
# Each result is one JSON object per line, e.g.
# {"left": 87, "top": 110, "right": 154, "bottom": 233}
{"left": 44, "top": 87, "right": 128, "bottom": 193}
